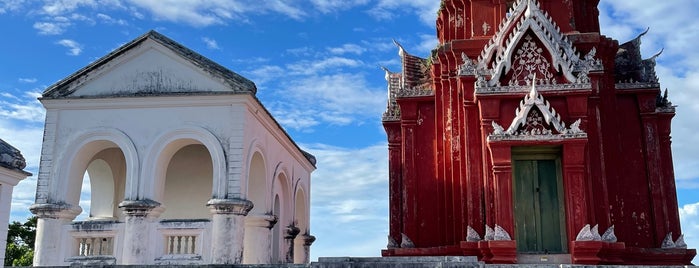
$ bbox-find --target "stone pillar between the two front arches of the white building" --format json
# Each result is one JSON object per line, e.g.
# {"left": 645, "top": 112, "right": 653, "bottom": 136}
{"left": 119, "top": 199, "right": 161, "bottom": 265}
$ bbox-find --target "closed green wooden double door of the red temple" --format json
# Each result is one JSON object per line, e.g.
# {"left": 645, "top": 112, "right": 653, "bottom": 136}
{"left": 513, "top": 159, "right": 567, "bottom": 253}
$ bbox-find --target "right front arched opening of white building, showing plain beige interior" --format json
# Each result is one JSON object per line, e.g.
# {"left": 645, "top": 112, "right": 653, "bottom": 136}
{"left": 160, "top": 144, "right": 213, "bottom": 220}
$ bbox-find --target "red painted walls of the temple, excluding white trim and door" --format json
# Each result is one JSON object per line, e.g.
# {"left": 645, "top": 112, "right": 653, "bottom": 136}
{"left": 382, "top": 0, "right": 695, "bottom": 264}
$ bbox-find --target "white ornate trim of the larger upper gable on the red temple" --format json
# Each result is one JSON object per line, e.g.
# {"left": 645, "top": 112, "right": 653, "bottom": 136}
{"left": 464, "top": 0, "right": 604, "bottom": 91}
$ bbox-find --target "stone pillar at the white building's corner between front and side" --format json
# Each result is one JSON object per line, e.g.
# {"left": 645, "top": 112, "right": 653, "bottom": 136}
{"left": 206, "top": 199, "right": 253, "bottom": 264}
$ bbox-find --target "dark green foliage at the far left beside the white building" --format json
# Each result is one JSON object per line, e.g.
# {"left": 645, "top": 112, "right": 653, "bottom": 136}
{"left": 5, "top": 217, "right": 36, "bottom": 267}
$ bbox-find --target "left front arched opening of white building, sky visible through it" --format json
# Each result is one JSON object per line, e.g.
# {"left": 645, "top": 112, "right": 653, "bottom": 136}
{"left": 71, "top": 146, "right": 126, "bottom": 221}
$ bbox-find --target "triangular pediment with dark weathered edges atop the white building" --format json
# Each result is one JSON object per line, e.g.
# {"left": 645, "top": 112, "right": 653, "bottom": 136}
{"left": 43, "top": 31, "right": 256, "bottom": 98}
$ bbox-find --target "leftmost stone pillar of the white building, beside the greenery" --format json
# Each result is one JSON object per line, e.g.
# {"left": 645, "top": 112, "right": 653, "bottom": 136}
{"left": 29, "top": 203, "right": 82, "bottom": 266}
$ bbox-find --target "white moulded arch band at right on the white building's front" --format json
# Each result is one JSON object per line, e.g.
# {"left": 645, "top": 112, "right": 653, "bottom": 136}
{"left": 143, "top": 126, "right": 228, "bottom": 201}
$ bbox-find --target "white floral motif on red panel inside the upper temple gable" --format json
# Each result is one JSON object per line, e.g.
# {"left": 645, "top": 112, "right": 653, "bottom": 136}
{"left": 509, "top": 35, "right": 553, "bottom": 86}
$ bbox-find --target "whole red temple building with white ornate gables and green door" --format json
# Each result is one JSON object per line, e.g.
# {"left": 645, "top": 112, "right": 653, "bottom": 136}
{"left": 382, "top": 0, "right": 696, "bottom": 265}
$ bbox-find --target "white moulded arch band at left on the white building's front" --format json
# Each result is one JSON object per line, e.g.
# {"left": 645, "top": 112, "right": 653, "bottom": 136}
{"left": 49, "top": 128, "right": 140, "bottom": 208}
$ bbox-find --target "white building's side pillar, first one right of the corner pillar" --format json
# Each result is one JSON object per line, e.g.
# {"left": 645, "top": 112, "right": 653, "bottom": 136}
{"left": 243, "top": 214, "right": 277, "bottom": 264}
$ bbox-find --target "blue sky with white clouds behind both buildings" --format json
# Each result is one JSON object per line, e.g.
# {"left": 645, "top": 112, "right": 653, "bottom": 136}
{"left": 0, "top": 0, "right": 699, "bottom": 259}
